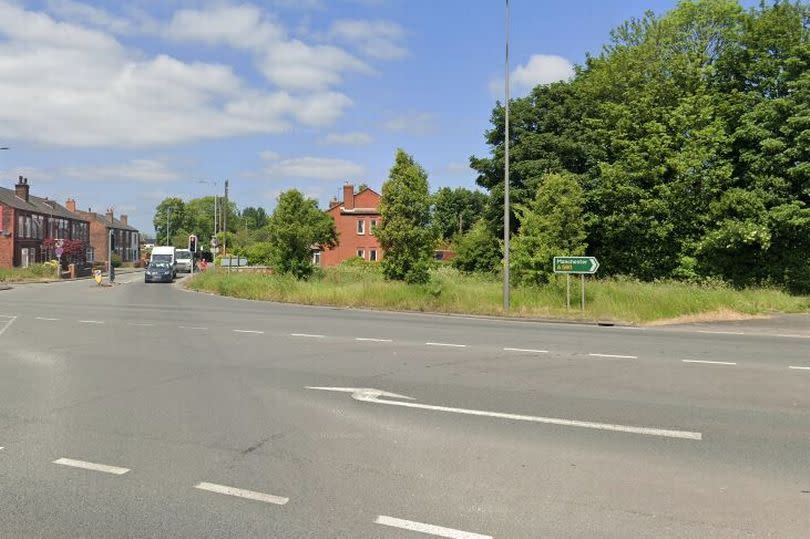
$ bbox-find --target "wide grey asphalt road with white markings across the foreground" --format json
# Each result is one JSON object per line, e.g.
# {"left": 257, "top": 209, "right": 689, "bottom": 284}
{"left": 0, "top": 275, "right": 810, "bottom": 539}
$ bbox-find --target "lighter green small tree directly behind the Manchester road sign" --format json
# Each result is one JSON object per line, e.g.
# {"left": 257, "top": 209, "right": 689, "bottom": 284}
{"left": 510, "top": 174, "right": 586, "bottom": 285}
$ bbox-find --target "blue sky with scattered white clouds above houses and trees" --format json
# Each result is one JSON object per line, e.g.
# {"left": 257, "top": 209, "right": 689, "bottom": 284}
{"left": 0, "top": 0, "right": 732, "bottom": 233}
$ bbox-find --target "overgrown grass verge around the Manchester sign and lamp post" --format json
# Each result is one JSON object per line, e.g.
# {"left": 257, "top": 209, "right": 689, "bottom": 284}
{"left": 186, "top": 267, "right": 810, "bottom": 323}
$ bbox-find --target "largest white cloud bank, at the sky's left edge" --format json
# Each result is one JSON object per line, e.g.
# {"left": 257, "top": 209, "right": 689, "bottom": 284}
{"left": 0, "top": 0, "right": 351, "bottom": 147}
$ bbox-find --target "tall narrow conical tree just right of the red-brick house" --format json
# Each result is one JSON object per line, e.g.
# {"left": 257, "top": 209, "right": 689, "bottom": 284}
{"left": 374, "top": 149, "right": 435, "bottom": 283}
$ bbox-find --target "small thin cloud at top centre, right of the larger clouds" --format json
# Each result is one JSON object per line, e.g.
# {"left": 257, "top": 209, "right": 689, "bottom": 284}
{"left": 329, "top": 19, "right": 408, "bottom": 60}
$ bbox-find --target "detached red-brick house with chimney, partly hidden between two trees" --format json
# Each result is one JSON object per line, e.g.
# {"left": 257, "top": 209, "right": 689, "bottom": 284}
{"left": 313, "top": 183, "right": 383, "bottom": 266}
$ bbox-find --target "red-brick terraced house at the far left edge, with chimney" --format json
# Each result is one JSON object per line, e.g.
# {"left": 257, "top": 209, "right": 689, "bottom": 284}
{"left": 0, "top": 176, "right": 93, "bottom": 268}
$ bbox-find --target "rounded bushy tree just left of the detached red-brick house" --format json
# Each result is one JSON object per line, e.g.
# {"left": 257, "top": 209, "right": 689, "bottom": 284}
{"left": 266, "top": 189, "right": 338, "bottom": 279}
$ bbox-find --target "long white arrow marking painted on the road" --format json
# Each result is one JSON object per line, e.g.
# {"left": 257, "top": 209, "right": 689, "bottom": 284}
{"left": 306, "top": 386, "right": 703, "bottom": 440}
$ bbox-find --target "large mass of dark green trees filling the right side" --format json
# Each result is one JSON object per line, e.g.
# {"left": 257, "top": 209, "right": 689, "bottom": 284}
{"left": 470, "top": 0, "right": 810, "bottom": 290}
